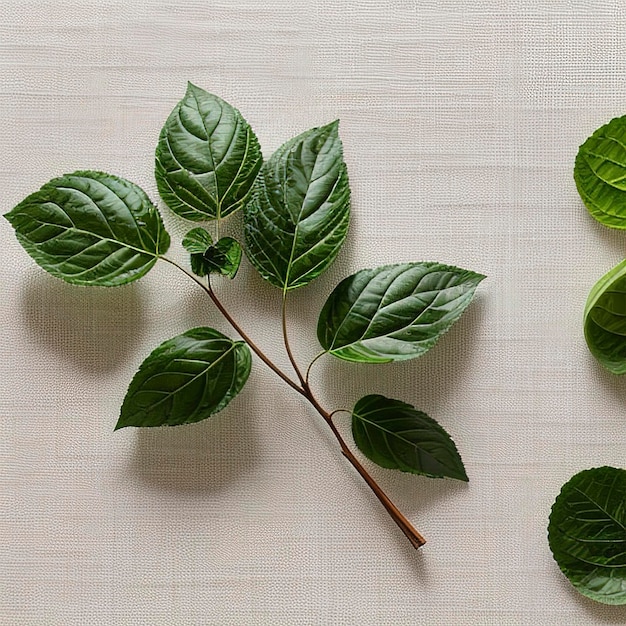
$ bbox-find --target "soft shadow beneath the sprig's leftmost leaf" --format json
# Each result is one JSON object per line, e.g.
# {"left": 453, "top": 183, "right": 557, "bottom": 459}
{"left": 20, "top": 272, "right": 144, "bottom": 374}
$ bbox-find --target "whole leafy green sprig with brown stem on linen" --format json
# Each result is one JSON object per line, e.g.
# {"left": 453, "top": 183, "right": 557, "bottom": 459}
{"left": 5, "top": 84, "right": 484, "bottom": 548}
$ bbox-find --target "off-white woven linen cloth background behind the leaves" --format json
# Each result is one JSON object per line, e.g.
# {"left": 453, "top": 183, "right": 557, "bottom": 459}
{"left": 0, "top": 0, "right": 626, "bottom": 626}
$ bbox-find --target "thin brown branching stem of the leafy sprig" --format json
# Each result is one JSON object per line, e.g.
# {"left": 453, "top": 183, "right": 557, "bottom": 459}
{"left": 160, "top": 256, "right": 426, "bottom": 549}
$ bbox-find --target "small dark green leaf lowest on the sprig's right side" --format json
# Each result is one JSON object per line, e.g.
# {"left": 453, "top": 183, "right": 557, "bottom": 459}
{"left": 352, "top": 395, "right": 468, "bottom": 481}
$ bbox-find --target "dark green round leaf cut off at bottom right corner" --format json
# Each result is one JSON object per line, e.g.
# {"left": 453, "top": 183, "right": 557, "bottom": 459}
{"left": 548, "top": 467, "right": 626, "bottom": 604}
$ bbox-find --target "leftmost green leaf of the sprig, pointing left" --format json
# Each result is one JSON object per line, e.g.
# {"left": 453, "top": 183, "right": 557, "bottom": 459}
{"left": 5, "top": 171, "right": 170, "bottom": 287}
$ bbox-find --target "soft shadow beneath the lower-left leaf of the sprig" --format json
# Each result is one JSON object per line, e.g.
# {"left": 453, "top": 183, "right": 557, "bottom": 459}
{"left": 129, "top": 381, "right": 259, "bottom": 493}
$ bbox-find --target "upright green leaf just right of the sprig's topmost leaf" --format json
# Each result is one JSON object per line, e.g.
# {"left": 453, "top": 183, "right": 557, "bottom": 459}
{"left": 244, "top": 122, "right": 350, "bottom": 291}
